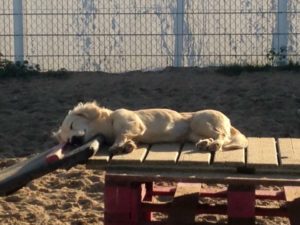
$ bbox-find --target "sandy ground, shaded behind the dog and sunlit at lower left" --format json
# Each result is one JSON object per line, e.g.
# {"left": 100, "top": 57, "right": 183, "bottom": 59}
{"left": 0, "top": 68, "right": 300, "bottom": 225}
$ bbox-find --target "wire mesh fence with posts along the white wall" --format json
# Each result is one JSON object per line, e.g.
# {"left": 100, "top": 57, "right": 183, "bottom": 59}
{"left": 0, "top": 0, "right": 300, "bottom": 72}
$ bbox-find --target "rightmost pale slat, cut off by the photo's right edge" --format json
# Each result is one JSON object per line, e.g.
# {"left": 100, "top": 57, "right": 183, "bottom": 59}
{"left": 278, "top": 138, "right": 300, "bottom": 168}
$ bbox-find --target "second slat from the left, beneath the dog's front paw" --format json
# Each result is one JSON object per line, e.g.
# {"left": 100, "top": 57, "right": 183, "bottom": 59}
{"left": 111, "top": 145, "right": 149, "bottom": 165}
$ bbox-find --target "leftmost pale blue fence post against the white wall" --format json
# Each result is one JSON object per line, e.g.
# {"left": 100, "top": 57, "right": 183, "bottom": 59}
{"left": 13, "top": 0, "right": 24, "bottom": 62}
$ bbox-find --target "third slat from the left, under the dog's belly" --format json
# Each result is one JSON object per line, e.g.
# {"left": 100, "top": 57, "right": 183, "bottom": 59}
{"left": 144, "top": 143, "right": 180, "bottom": 166}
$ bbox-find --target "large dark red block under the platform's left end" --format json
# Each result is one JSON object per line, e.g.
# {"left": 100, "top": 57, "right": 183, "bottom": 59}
{"left": 104, "top": 175, "right": 141, "bottom": 225}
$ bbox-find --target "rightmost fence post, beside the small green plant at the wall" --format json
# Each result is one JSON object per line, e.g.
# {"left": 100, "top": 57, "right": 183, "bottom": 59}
{"left": 272, "top": 0, "right": 288, "bottom": 65}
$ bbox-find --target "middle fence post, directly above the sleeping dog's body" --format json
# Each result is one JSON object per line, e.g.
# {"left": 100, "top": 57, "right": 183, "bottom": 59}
{"left": 173, "top": 0, "right": 185, "bottom": 67}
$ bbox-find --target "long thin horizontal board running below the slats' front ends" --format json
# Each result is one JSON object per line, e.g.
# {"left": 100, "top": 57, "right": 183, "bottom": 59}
{"left": 107, "top": 171, "right": 300, "bottom": 186}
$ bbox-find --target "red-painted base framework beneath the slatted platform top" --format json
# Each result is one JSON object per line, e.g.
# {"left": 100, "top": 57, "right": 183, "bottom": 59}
{"left": 104, "top": 174, "right": 300, "bottom": 225}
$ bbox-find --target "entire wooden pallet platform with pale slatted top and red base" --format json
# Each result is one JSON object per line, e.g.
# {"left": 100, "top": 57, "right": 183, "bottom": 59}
{"left": 88, "top": 137, "right": 300, "bottom": 225}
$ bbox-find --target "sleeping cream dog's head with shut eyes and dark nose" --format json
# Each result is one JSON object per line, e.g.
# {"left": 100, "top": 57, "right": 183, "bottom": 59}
{"left": 53, "top": 102, "right": 109, "bottom": 145}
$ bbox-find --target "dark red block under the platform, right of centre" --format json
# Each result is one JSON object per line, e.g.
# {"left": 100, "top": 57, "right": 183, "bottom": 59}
{"left": 227, "top": 185, "right": 255, "bottom": 225}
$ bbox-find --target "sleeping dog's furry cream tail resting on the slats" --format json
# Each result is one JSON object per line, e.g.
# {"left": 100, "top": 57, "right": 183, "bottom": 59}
{"left": 223, "top": 127, "right": 248, "bottom": 150}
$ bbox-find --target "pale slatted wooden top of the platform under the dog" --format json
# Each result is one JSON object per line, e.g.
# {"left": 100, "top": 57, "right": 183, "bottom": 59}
{"left": 88, "top": 137, "right": 300, "bottom": 185}
